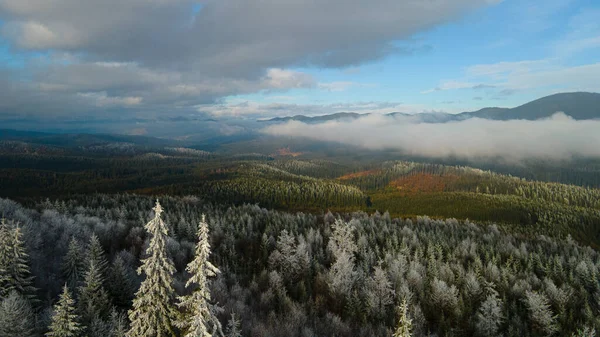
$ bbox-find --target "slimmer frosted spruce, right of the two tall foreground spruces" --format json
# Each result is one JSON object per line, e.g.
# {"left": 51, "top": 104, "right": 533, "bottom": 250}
{"left": 178, "top": 215, "right": 222, "bottom": 337}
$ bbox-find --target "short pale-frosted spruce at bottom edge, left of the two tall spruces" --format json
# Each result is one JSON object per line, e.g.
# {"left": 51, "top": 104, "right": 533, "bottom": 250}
{"left": 46, "top": 284, "right": 82, "bottom": 337}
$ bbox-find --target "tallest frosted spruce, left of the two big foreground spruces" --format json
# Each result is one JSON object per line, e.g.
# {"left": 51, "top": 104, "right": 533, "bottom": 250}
{"left": 127, "top": 201, "right": 177, "bottom": 337}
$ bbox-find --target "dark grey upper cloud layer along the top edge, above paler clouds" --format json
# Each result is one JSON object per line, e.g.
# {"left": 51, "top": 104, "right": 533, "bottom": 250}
{"left": 0, "top": 0, "right": 494, "bottom": 74}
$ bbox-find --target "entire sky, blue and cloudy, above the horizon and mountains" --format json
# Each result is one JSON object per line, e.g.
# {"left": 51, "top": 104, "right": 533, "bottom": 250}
{"left": 0, "top": 0, "right": 600, "bottom": 123}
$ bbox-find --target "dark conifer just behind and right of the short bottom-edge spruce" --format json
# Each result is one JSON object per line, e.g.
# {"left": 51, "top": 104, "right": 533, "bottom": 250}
{"left": 79, "top": 260, "right": 110, "bottom": 324}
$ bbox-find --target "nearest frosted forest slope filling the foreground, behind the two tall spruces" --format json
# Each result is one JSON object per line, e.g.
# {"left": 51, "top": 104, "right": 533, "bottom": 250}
{"left": 0, "top": 195, "right": 600, "bottom": 336}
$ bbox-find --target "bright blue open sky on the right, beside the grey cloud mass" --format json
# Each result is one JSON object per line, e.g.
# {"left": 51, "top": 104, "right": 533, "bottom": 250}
{"left": 228, "top": 0, "right": 600, "bottom": 112}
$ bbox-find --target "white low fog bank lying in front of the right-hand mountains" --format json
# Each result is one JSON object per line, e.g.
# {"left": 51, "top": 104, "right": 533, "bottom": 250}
{"left": 262, "top": 112, "right": 600, "bottom": 162}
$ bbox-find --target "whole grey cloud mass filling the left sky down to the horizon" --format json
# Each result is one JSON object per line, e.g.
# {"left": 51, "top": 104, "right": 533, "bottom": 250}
{"left": 0, "top": 0, "right": 495, "bottom": 118}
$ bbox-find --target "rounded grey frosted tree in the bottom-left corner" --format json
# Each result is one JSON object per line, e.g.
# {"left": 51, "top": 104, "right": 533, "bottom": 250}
{"left": 0, "top": 290, "right": 37, "bottom": 337}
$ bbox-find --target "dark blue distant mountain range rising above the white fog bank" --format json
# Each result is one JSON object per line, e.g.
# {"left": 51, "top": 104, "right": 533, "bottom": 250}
{"left": 265, "top": 92, "right": 600, "bottom": 124}
